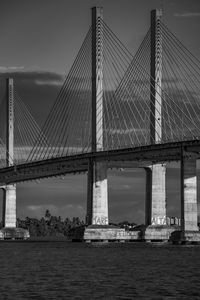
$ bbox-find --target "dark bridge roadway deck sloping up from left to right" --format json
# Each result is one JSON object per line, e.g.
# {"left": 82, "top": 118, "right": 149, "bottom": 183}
{"left": 0, "top": 139, "right": 200, "bottom": 185}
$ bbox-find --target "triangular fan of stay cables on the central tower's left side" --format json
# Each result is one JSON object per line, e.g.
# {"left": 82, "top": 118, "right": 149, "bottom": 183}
{"left": 28, "top": 29, "right": 92, "bottom": 161}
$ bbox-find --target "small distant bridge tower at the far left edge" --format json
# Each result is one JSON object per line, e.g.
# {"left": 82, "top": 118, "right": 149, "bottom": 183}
{"left": 3, "top": 78, "right": 16, "bottom": 228}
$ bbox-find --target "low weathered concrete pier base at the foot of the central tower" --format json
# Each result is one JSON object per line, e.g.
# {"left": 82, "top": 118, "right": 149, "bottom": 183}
{"left": 84, "top": 225, "right": 142, "bottom": 242}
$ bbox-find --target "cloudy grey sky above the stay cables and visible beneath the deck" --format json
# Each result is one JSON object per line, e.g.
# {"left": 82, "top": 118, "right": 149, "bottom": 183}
{"left": 0, "top": 0, "right": 200, "bottom": 223}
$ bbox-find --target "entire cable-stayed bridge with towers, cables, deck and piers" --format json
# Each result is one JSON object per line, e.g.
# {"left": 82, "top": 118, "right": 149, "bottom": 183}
{"left": 0, "top": 7, "right": 200, "bottom": 242}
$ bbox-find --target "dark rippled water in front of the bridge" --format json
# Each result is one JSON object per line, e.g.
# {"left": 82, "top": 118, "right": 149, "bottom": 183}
{"left": 0, "top": 242, "right": 200, "bottom": 300}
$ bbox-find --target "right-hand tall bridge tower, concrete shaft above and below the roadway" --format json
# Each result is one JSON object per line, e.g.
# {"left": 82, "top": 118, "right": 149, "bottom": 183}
{"left": 145, "top": 9, "right": 173, "bottom": 240}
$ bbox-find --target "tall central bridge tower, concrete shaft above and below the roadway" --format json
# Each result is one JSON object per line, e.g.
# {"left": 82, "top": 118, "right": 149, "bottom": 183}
{"left": 86, "top": 7, "right": 108, "bottom": 225}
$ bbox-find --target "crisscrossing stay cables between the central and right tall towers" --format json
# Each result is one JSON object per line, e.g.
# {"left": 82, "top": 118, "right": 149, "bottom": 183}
{"left": 102, "top": 21, "right": 150, "bottom": 150}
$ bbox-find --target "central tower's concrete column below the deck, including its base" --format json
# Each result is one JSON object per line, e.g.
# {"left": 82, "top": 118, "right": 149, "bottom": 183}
{"left": 84, "top": 162, "right": 129, "bottom": 242}
